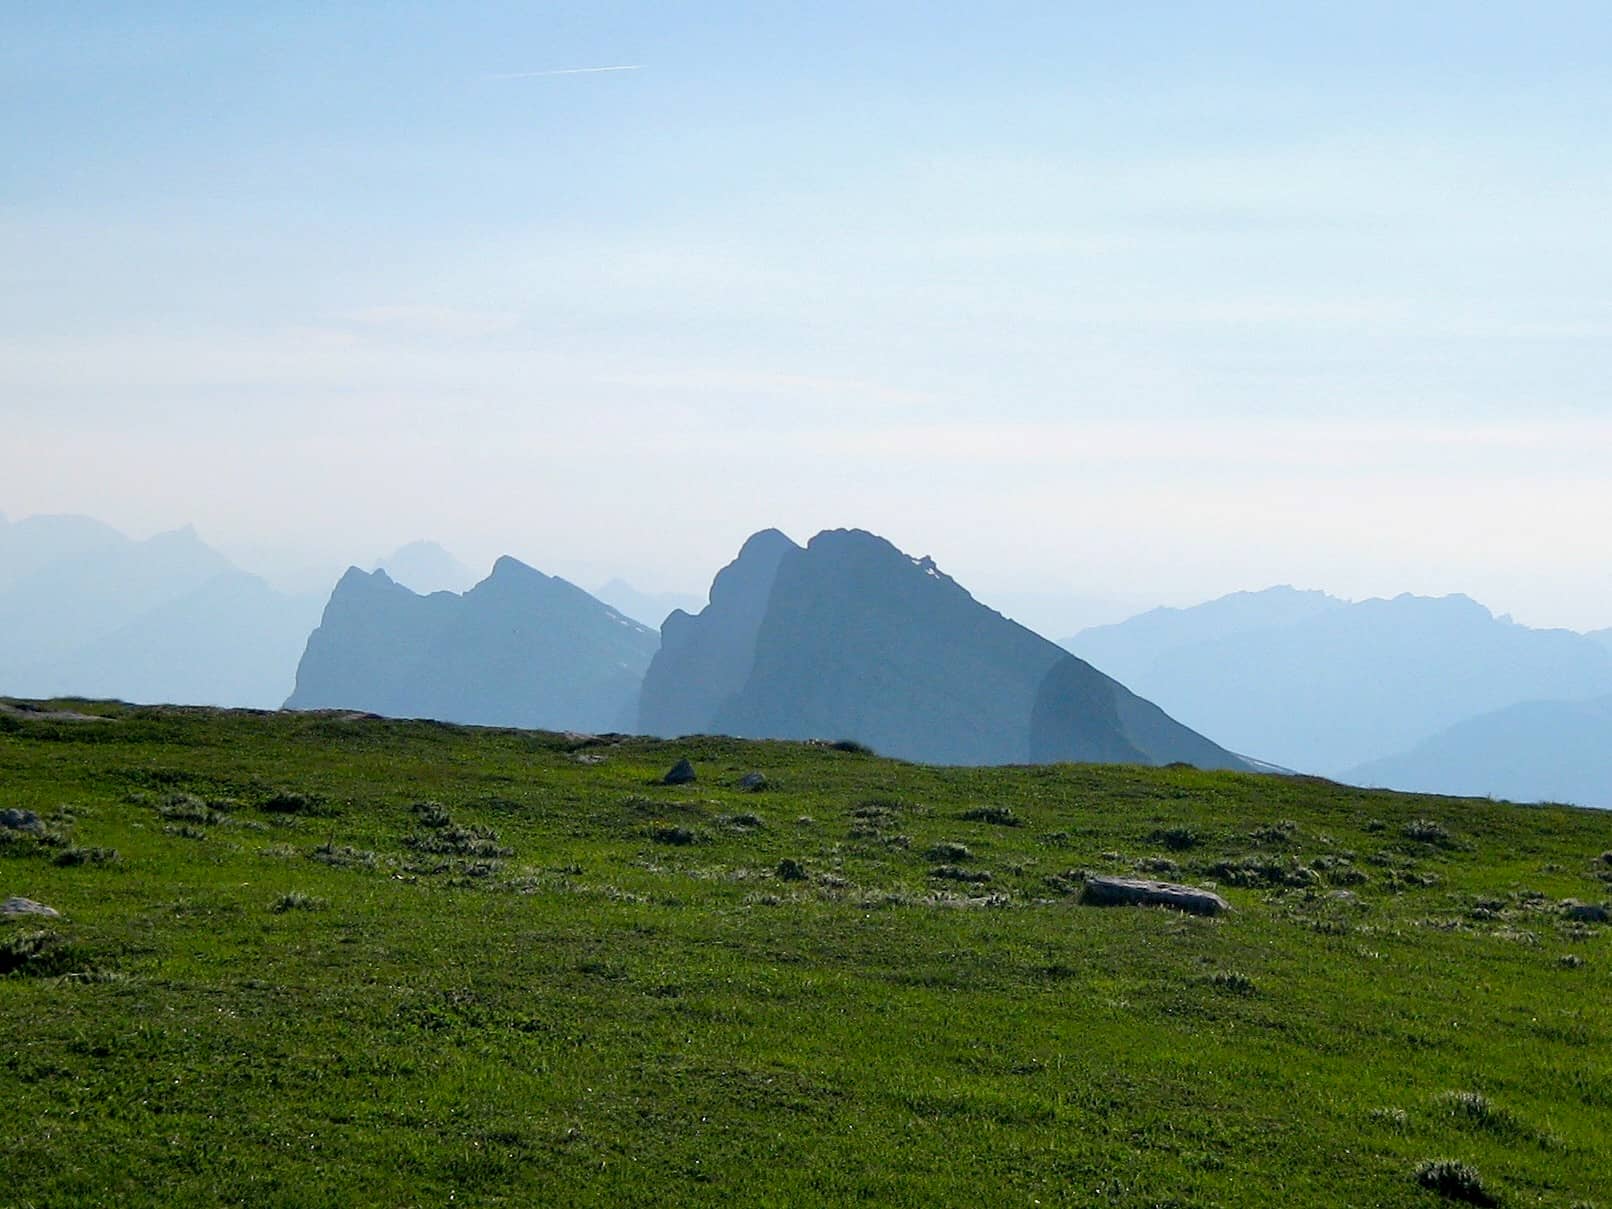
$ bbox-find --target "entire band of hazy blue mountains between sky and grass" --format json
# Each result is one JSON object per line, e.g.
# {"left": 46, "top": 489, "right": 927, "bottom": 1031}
{"left": 12, "top": 516, "right": 1612, "bottom": 806}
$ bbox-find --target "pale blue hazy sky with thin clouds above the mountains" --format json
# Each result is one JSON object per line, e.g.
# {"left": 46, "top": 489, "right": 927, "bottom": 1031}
{"left": 0, "top": 0, "right": 1612, "bottom": 637}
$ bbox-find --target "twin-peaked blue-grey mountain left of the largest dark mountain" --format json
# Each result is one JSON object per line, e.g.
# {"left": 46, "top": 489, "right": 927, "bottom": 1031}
{"left": 285, "top": 556, "right": 658, "bottom": 730}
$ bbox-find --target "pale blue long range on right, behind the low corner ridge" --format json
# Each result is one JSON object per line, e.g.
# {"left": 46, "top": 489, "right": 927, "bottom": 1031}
{"left": 1067, "top": 587, "right": 1612, "bottom": 775}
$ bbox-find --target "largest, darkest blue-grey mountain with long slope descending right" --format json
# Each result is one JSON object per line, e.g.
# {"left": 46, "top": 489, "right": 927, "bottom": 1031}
{"left": 638, "top": 529, "right": 1248, "bottom": 767}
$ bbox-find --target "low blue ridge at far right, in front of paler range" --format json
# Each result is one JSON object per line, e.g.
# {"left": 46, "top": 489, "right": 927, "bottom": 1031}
{"left": 1343, "top": 696, "right": 1612, "bottom": 808}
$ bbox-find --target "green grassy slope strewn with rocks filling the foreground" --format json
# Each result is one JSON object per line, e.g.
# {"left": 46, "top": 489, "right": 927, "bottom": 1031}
{"left": 0, "top": 706, "right": 1612, "bottom": 1207}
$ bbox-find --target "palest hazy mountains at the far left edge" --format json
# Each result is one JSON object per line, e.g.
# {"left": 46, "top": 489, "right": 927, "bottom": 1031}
{"left": 0, "top": 516, "right": 319, "bottom": 709}
